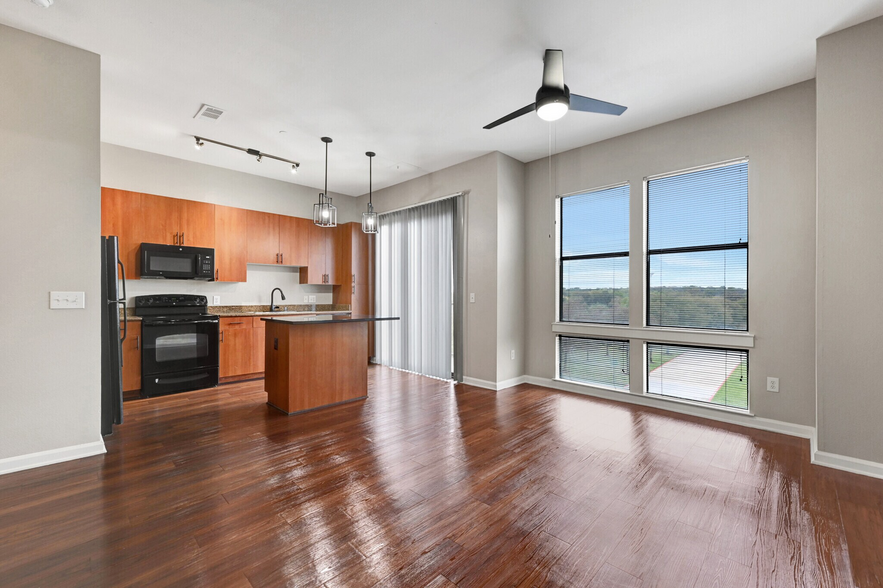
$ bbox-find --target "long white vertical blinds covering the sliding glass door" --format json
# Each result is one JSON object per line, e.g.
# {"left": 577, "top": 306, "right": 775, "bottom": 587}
{"left": 375, "top": 198, "right": 457, "bottom": 380}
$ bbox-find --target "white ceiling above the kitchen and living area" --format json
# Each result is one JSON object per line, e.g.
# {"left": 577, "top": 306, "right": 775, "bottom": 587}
{"left": 0, "top": 0, "right": 883, "bottom": 195}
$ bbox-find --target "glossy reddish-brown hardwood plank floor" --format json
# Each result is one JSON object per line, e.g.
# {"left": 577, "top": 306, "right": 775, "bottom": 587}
{"left": 0, "top": 367, "right": 883, "bottom": 588}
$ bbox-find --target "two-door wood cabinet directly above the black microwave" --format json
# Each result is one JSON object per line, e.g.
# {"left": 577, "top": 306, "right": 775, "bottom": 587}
{"left": 141, "top": 194, "right": 215, "bottom": 247}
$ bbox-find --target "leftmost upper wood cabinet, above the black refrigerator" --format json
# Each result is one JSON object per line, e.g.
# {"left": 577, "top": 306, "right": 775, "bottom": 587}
{"left": 101, "top": 188, "right": 141, "bottom": 280}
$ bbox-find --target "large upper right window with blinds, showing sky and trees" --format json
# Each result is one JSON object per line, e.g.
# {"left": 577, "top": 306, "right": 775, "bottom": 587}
{"left": 647, "top": 160, "right": 748, "bottom": 331}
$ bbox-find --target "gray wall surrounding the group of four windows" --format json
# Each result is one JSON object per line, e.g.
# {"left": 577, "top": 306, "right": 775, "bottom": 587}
{"left": 526, "top": 81, "right": 816, "bottom": 425}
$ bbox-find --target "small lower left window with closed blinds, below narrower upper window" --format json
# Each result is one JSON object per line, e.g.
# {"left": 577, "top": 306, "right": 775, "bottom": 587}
{"left": 558, "top": 336, "right": 629, "bottom": 390}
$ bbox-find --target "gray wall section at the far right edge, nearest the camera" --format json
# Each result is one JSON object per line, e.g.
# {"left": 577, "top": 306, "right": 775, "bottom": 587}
{"left": 816, "top": 18, "right": 883, "bottom": 462}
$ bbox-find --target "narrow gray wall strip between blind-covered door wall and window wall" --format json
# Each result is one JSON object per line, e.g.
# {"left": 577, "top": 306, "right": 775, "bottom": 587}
{"left": 496, "top": 154, "right": 525, "bottom": 382}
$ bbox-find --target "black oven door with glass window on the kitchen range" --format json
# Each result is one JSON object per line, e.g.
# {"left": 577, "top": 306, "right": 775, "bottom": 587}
{"left": 141, "top": 317, "right": 219, "bottom": 376}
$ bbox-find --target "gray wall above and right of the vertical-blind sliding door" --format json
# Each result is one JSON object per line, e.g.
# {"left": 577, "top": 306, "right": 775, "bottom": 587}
{"left": 359, "top": 153, "right": 501, "bottom": 382}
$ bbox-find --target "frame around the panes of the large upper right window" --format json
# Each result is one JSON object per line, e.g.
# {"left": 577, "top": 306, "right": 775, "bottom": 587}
{"left": 644, "top": 157, "right": 751, "bottom": 330}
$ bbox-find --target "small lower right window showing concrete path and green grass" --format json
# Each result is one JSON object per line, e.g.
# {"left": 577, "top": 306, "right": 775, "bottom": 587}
{"left": 647, "top": 343, "right": 748, "bottom": 410}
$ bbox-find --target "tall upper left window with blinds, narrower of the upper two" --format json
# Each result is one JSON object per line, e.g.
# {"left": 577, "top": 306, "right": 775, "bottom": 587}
{"left": 559, "top": 184, "right": 629, "bottom": 325}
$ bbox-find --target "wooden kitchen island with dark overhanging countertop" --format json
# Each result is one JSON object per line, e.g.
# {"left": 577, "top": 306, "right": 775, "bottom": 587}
{"left": 261, "top": 315, "right": 398, "bottom": 415}
